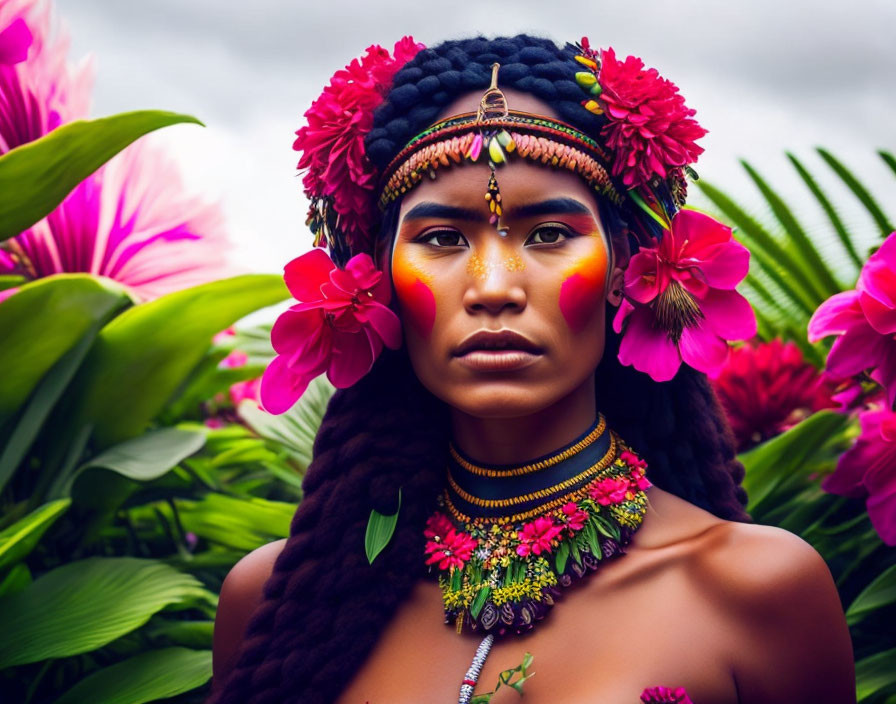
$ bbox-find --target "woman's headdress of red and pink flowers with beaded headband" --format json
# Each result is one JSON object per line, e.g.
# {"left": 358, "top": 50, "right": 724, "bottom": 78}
{"left": 261, "top": 36, "right": 756, "bottom": 413}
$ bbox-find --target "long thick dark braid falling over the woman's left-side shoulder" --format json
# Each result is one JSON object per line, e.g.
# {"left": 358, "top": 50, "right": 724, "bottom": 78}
{"left": 209, "top": 352, "right": 447, "bottom": 704}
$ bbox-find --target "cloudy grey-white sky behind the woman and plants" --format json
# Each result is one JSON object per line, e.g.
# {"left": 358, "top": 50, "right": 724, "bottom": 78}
{"left": 56, "top": 0, "right": 896, "bottom": 272}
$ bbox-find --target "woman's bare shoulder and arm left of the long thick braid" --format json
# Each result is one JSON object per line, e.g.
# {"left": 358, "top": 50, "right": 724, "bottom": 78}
{"left": 212, "top": 538, "right": 286, "bottom": 687}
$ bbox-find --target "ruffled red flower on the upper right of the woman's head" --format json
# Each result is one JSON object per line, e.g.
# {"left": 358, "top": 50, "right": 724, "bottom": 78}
{"left": 597, "top": 49, "right": 706, "bottom": 188}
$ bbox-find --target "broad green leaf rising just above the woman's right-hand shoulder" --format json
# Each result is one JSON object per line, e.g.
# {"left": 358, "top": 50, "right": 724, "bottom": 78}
{"left": 738, "top": 411, "right": 851, "bottom": 518}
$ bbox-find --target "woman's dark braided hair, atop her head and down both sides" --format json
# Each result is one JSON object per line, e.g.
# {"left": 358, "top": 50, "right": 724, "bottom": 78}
{"left": 209, "top": 35, "right": 749, "bottom": 704}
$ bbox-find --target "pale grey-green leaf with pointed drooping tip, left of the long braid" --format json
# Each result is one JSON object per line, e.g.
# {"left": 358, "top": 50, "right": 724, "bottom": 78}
{"left": 50, "top": 428, "right": 205, "bottom": 496}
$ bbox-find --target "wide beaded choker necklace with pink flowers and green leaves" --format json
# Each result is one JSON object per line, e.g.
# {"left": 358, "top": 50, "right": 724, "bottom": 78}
{"left": 424, "top": 415, "right": 651, "bottom": 635}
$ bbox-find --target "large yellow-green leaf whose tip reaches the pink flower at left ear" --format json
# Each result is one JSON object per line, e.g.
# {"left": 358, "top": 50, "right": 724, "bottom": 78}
{"left": 66, "top": 274, "right": 289, "bottom": 448}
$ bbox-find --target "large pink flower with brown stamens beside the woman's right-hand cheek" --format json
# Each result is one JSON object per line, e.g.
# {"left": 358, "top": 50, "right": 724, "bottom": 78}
{"left": 613, "top": 210, "right": 756, "bottom": 381}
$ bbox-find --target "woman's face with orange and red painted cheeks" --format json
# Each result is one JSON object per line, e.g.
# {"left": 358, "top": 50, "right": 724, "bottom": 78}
{"left": 391, "top": 153, "right": 622, "bottom": 418}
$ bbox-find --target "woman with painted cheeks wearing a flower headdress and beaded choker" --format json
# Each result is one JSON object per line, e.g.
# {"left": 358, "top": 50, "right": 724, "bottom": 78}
{"left": 212, "top": 35, "right": 855, "bottom": 704}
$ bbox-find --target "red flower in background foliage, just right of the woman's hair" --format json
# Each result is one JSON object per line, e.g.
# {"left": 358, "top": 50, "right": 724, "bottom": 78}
{"left": 712, "top": 338, "right": 836, "bottom": 452}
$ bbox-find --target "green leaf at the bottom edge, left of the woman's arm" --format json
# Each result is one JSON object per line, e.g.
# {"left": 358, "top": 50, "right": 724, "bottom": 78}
{"left": 54, "top": 647, "right": 212, "bottom": 704}
